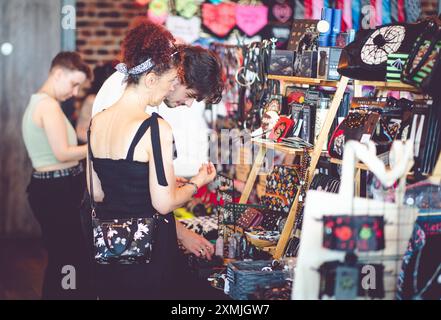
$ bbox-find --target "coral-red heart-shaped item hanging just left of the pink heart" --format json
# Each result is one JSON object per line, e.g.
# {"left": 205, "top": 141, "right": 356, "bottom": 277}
{"left": 202, "top": 3, "right": 236, "bottom": 37}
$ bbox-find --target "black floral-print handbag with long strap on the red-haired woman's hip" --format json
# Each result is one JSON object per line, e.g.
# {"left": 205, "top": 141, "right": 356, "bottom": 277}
{"left": 87, "top": 121, "right": 159, "bottom": 264}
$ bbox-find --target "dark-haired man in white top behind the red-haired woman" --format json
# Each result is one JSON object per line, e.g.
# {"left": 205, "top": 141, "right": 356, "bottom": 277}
{"left": 92, "top": 45, "right": 223, "bottom": 177}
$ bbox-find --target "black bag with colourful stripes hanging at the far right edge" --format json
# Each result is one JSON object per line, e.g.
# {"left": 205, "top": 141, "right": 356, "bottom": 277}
{"left": 401, "top": 19, "right": 441, "bottom": 99}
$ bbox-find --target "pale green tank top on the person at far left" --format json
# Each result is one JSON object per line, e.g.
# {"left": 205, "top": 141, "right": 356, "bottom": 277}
{"left": 22, "top": 93, "right": 78, "bottom": 168}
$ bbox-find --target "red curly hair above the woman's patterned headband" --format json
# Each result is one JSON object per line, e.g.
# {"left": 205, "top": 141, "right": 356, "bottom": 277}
{"left": 122, "top": 18, "right": 182, "bottom": 84}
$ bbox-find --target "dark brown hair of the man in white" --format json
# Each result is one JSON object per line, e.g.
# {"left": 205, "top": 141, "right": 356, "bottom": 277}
{"left": 178, "top": 45, "right": 224, "bottom": 104}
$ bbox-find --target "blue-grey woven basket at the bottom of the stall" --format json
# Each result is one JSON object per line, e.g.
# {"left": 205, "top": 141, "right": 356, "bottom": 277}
{"left": 227, "top": 261, "right": 288, "bottom": 300}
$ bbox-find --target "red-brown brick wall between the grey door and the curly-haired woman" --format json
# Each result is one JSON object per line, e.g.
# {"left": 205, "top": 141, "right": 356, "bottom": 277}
{"left": 76, "top": 0, "right": 147, "bottom": 69}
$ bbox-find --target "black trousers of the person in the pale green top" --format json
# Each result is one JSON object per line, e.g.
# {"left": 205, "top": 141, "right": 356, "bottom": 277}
{"left": 28, "top": 172, "right": 96, "bottom": 300}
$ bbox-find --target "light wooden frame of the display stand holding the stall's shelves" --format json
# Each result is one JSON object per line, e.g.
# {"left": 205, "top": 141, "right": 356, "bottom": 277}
{"left": 240, "top": 75, "right": 428, "bottom": 259}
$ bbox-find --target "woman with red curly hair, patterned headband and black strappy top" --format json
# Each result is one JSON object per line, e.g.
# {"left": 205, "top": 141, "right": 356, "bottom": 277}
{"left": 85, "top": 21, "right": 216, "bottom": 299}
